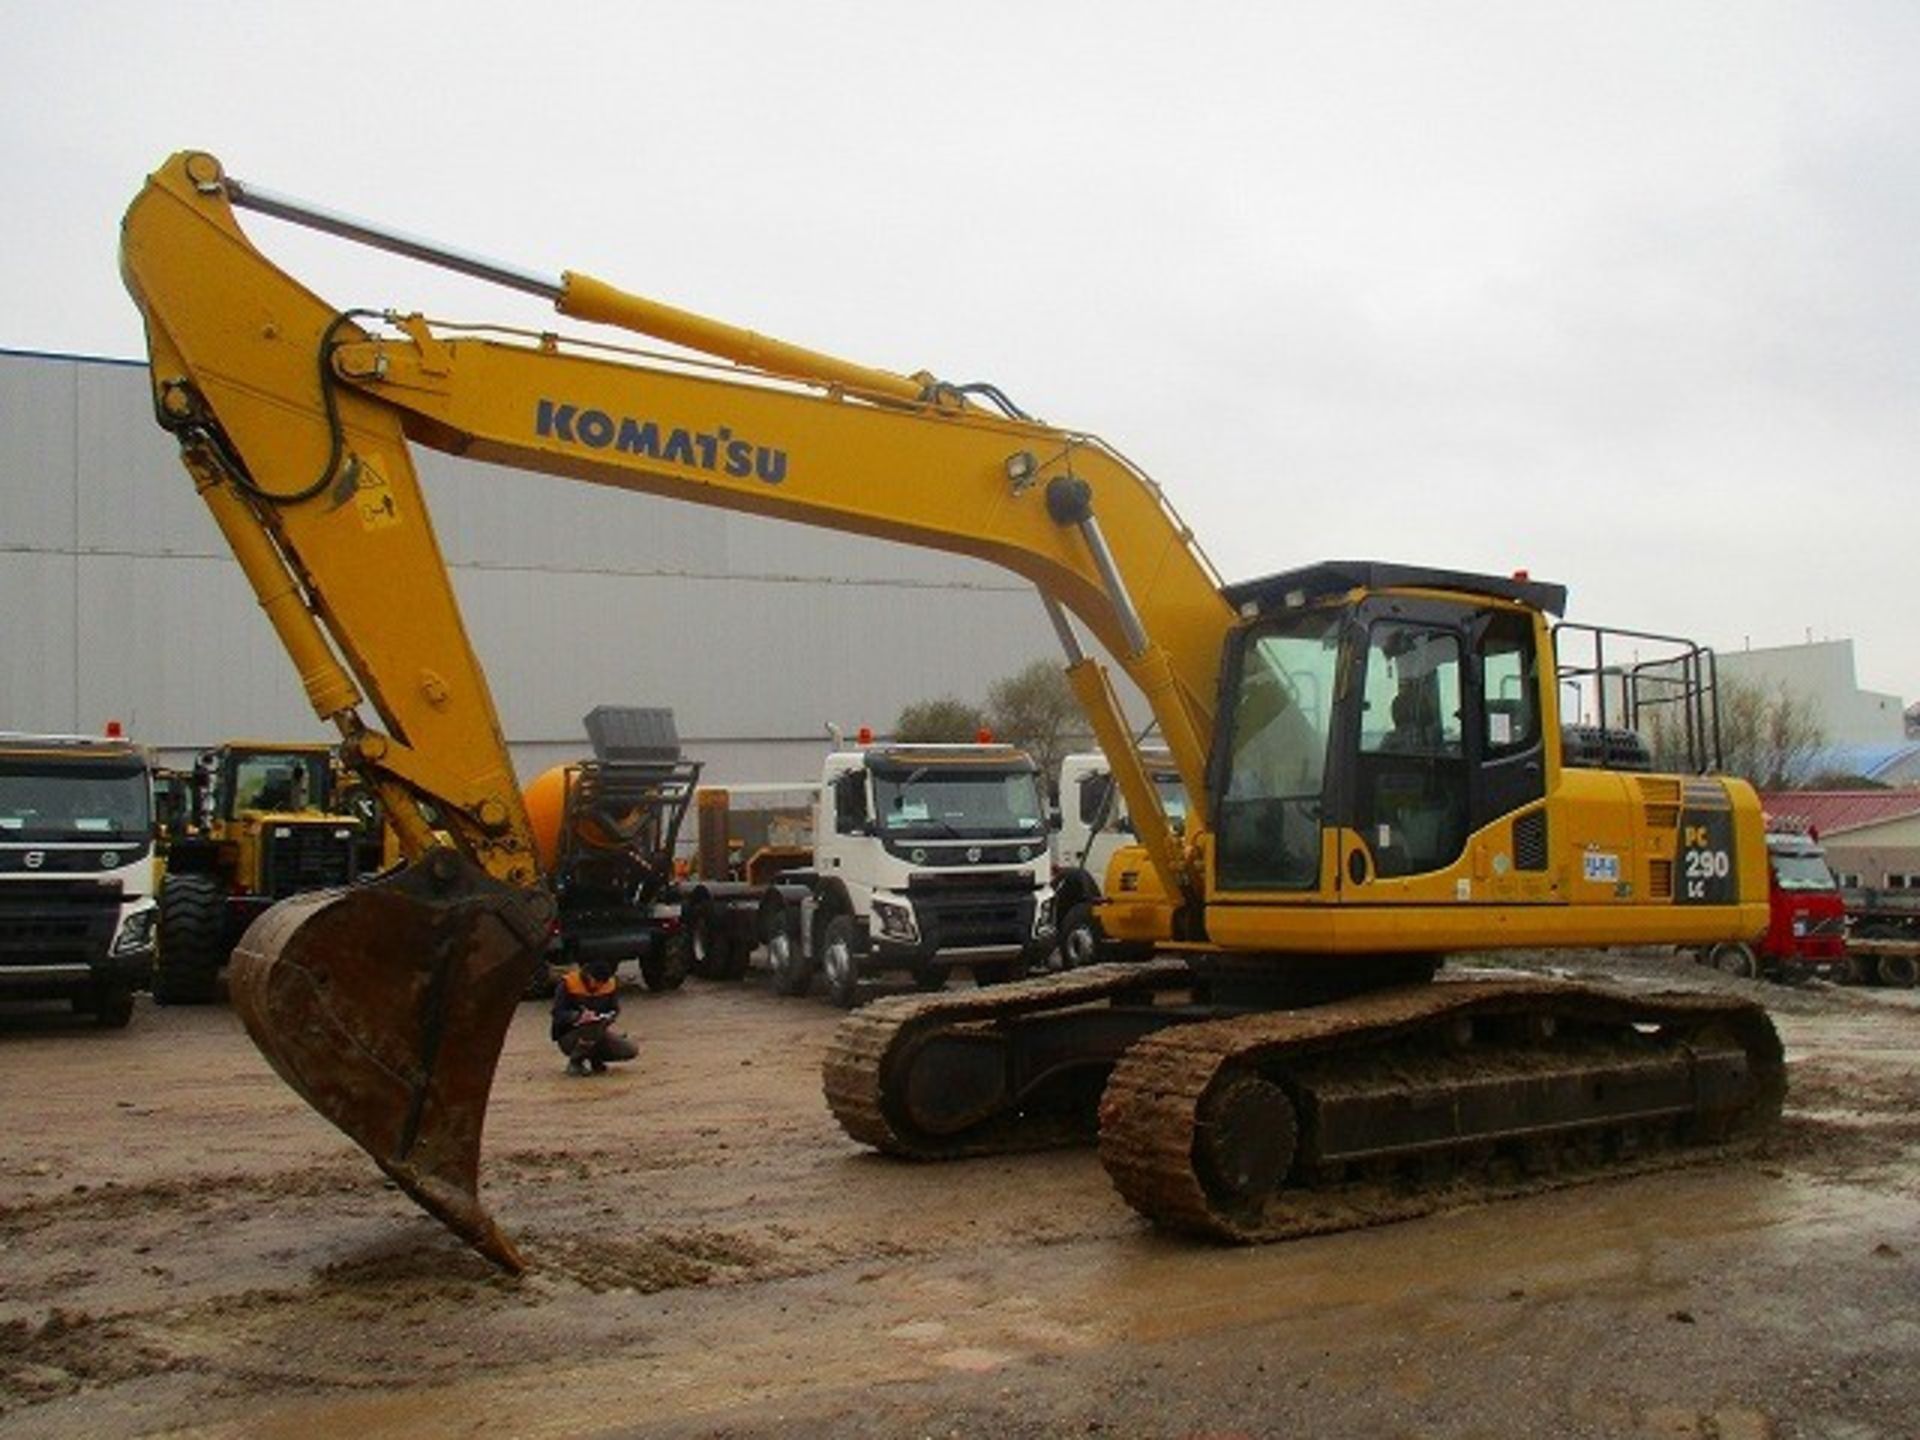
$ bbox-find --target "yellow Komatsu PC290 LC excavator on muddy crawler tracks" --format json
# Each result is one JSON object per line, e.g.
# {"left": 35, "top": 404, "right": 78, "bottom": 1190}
{"left": 121, "top": 154, "right": 1786, "bottom": 1267}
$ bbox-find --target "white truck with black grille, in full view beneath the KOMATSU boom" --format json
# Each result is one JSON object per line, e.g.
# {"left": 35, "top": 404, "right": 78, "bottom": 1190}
{"left": 762, "top": 745, "right": 1054, "bottom": 1006}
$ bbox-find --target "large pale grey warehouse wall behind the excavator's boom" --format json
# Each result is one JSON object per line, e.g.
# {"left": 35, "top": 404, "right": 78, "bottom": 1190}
{"left": 0, "top": 351, "right": 1082, "bottom": 783}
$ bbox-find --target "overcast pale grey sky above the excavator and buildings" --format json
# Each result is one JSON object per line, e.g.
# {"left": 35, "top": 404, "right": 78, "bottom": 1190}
{"left": 0, "top": 0, "right": 1920, "bottom": 699}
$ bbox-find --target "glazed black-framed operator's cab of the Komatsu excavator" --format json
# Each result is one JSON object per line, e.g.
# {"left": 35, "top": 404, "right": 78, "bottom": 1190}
{"left": 1210, "top": 564, "right": 1563, "bottom": 902}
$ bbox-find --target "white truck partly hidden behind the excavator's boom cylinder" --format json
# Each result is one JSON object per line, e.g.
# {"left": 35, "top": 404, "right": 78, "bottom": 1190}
{"left": 1054, "top": 749, "right": 1187, "bottom": 970}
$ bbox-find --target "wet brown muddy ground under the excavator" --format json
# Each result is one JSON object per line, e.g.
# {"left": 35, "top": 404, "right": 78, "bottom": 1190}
{"left": 0, "top": 956, "right": 1920, "bottom": 1440}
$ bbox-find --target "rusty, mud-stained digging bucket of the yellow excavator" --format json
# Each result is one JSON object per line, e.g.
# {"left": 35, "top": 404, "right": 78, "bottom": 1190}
{"left": 230, "top": 851, "right": 545, "bottom": 1273}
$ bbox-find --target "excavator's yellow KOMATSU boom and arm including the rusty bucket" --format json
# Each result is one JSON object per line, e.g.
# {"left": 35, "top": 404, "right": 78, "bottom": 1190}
{"left": 121, "top": 154, "right": 1235, "bottom": 1267}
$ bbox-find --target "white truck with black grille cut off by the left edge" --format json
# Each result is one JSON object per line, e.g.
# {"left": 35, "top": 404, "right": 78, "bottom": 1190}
{"left": 0, "top": 733, "right": 157, "bottom": 1027}
